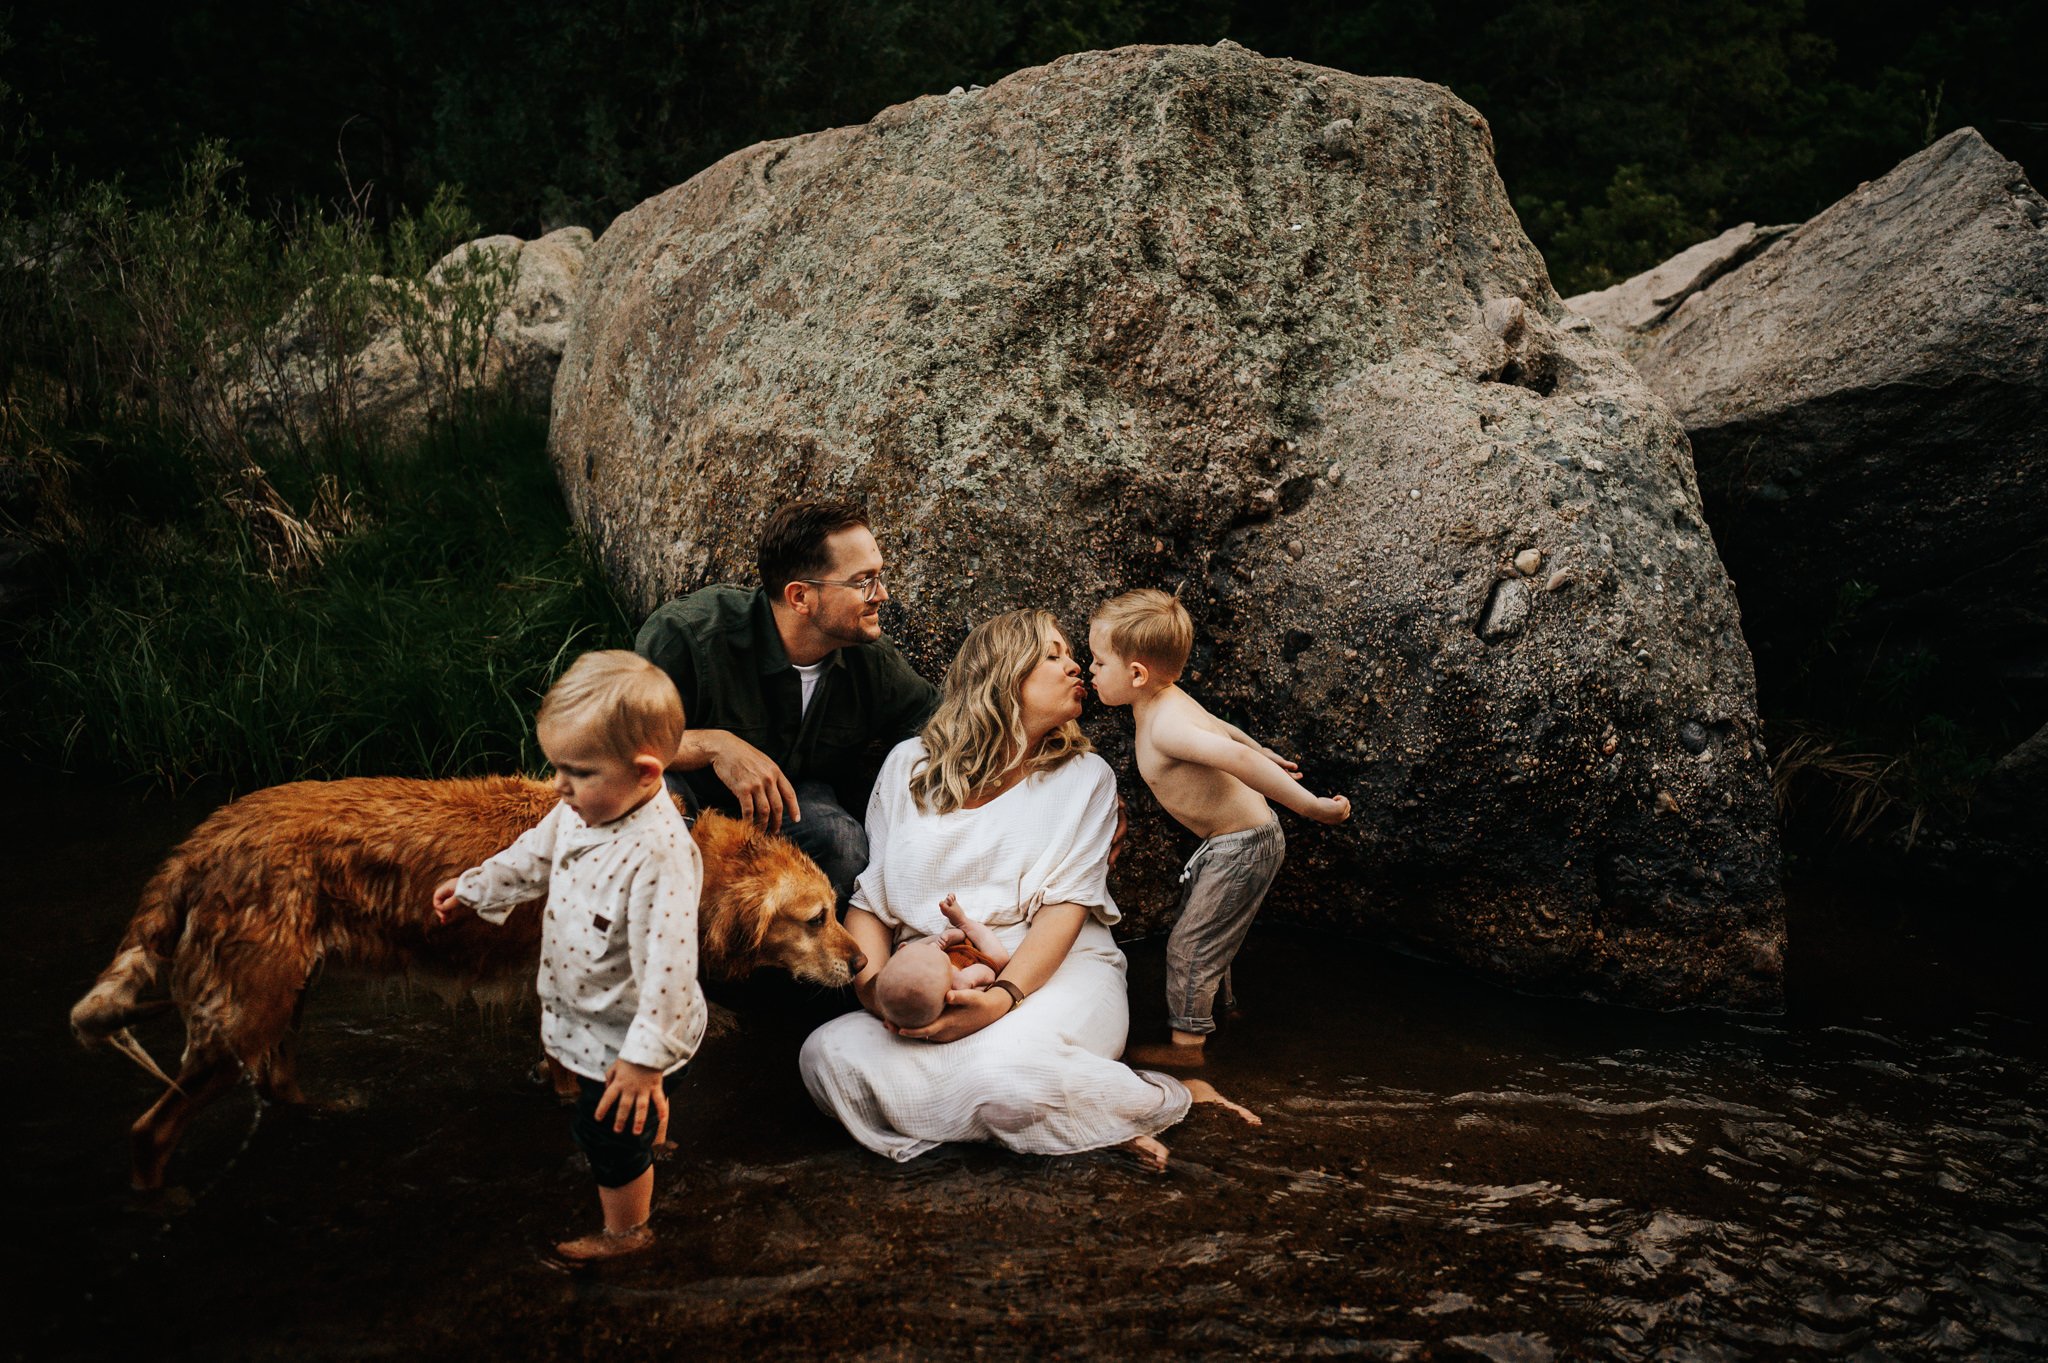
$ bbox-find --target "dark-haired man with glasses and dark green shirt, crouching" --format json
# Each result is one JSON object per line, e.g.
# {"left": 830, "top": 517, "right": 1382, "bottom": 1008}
{"left": 633, "top": 501, "right": 938, "bottom": 905}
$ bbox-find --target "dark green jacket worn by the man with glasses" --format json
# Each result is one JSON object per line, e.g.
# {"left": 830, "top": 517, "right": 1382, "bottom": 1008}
{"left": 633, "top": 587, "right": 938, "bottom": 819}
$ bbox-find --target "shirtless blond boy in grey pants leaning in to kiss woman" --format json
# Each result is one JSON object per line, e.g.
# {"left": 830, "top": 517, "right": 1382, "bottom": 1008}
{"left": 1087, "top": 587, "right": 1352, "bottom": 1066}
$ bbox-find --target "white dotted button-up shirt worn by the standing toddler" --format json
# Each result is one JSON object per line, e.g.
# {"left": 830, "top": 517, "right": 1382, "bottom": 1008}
{"left": 455, "top": 796, "right": 705, "bottom": 1081}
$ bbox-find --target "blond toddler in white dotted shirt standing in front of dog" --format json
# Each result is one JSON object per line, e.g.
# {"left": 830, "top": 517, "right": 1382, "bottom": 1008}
{"left": 434, "top": 649, "right": 705, "bottom": 1263}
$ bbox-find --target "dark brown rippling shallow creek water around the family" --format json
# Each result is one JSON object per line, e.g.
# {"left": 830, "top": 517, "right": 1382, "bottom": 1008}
{"left": 0, "top": 782, "right": 2048, "bottom": 1363}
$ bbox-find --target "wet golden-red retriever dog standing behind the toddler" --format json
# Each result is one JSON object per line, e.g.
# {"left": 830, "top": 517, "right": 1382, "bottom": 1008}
{"left": 72, "top": 778, "right": 864, "bottom": 1191}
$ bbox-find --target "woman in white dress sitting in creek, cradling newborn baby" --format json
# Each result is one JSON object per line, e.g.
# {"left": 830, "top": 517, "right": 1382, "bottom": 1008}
{"left": 801, "top": 610, "right": 1257, "bottom": 1169}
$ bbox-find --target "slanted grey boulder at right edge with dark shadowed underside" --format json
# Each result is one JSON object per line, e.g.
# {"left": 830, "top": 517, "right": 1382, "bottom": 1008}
{"left": 1569, "top": 129, "right": 2048, "bottom": 757}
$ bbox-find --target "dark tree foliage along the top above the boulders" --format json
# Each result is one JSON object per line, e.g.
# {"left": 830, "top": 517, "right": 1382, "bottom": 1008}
{"left": 0, "top": 0, "right": 2048, "bottom": 293}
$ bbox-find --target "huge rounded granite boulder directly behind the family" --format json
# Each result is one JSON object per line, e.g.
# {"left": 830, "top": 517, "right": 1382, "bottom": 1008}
{"left": 551, "top": 43, "right": 1784, "bottom": 1007}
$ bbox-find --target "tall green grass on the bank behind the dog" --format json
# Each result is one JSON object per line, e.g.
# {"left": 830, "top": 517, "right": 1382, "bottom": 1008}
{"left": 6, "top": 405, "right": 631, "bottom": 788}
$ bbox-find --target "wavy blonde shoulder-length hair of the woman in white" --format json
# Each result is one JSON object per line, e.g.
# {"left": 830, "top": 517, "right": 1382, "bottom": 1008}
{"left": 909, "top": 610, "right": 1094, "bottom": 815}
